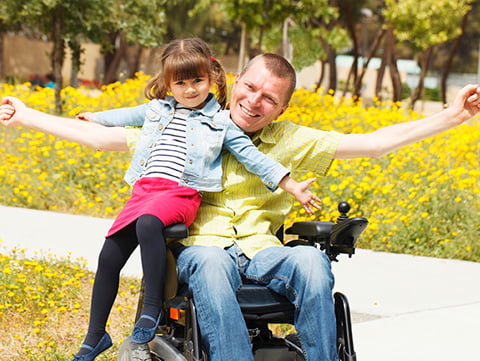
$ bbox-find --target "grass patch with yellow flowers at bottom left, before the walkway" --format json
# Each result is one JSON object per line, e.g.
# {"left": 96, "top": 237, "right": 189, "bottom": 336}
{"left": 0, "top": 249, "right": 140, "bottom": 361}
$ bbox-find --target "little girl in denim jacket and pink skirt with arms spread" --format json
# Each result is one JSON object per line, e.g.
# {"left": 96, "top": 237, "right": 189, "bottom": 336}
{"left": 0, "top": 39, "right": 319, "bottom": 361}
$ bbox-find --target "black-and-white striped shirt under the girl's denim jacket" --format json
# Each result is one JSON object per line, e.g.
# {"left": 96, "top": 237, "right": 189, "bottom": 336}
{"left": 142, "top": 104, "right": 192, "bottom": 182}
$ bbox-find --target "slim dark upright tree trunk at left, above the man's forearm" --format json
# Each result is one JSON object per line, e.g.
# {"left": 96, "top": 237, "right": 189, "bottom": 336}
{"left": 51, "top": 7, "right": 65, "bottom": 114}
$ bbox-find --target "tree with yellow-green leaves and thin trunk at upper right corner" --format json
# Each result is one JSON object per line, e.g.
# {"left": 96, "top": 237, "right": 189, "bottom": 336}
{"left": 383, "top": 0, "right": 471, "bottom": 108}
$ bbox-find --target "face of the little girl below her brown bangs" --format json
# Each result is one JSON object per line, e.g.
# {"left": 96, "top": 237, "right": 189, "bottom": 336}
{"left": 169, "top": 76, "right": 212, "bottom": 109}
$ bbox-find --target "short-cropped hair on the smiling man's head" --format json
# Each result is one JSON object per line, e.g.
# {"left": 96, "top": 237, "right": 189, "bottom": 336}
{"left": 240, "top": 53, "right": 297, "bottom": 104}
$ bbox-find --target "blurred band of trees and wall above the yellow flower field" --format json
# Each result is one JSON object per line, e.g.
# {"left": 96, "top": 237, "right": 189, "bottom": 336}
{"left": 0, "top": 0, "right": 480, "bottom": 112}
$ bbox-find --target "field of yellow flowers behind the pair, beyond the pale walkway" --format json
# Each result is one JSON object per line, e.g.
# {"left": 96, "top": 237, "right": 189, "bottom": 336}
{"left": 0, "top": 74, "right": 480, "bottom": 261}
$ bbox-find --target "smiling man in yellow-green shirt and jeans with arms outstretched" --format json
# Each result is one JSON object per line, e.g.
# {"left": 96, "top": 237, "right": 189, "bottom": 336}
{"left": 0, "top": 54, "right": 480, "bottom": 361}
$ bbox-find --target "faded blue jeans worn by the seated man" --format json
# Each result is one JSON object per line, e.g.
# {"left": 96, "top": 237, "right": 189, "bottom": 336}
{"left": 174, "top": 245, "right": 338, "bottom": 361}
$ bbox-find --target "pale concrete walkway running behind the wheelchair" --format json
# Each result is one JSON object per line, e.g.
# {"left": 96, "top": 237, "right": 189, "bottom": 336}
{"left": 0, "top": 206, "right": 480, "bottom": 361}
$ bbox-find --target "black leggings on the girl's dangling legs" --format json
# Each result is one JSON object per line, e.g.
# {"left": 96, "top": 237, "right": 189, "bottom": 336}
{"left": 84, "top": 214, "right": 166, "bottom": 346}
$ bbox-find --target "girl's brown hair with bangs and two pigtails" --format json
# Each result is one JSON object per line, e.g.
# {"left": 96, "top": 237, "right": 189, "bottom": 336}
{"left": 144, "top": 38, "right": 227, "bottom": 109}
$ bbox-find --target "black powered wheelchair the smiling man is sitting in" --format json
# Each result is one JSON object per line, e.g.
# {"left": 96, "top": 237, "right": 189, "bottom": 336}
{"left": 117, "top": 202, "right": 368, "bottom": 361}
